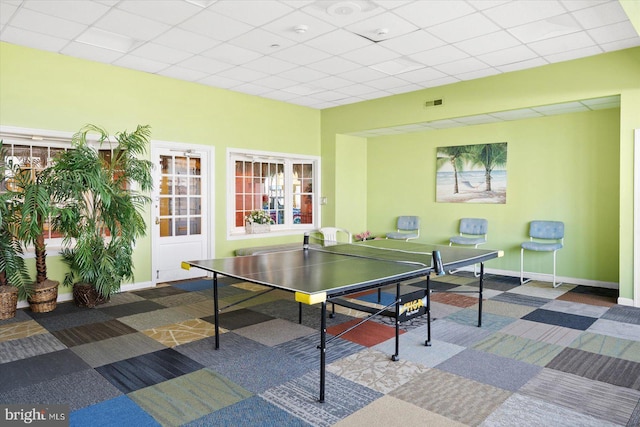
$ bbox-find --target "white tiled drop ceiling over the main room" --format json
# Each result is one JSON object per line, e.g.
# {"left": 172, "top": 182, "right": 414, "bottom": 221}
{"left": 0, "top": 0, "right": 640, "bottom": 110}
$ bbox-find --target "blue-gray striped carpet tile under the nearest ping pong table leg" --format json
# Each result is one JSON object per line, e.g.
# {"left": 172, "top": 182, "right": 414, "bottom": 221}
{"left": 260, "top": 371, "right": 382, "bottom": 426}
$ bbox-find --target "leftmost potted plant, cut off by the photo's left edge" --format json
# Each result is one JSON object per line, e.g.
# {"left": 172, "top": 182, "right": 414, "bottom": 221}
{"left": 0, "top": 141, "right": 30, "bottom": 320}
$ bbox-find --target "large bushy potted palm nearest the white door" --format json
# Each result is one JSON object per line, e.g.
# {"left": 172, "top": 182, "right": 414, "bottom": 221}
{"left": 49, "top": 125, "right": 153, "bottom": 307}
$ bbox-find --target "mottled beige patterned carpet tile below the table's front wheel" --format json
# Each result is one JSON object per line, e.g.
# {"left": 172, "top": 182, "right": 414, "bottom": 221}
{"left": 327, "top": 349, "right": 429, "bottom": 394}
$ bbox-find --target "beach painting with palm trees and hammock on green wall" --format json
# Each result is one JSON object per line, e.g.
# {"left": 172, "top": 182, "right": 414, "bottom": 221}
{"left": 436, "top": 142, "right": 507, "bottom": 204}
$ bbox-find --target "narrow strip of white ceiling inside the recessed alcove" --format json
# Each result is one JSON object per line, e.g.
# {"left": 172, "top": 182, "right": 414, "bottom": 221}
{"left": 348, "top": 95, "right": 620, "bottom": 138}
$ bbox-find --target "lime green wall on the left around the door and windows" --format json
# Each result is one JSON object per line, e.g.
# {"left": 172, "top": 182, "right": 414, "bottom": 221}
{"left": 0, "top": 43, "right": 321, "bottom": 298}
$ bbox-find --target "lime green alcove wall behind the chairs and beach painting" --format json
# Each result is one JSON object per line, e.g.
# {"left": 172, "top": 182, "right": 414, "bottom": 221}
{"left": 367, "top": 109, "right": 619, "bottom": 283}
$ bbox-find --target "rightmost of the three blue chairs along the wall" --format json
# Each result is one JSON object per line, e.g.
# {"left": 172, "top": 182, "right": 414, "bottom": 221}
{"left": 520, "top": 221, "right": 564, "bottom": 288}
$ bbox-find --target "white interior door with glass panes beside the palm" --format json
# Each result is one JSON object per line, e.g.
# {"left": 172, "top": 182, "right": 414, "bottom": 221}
{"left": 152, "top": 143, "right": 213, "bottom": 283}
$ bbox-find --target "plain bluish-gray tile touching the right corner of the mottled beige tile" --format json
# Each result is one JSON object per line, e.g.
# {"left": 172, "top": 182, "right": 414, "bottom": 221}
{"left": 436, "top": 349, "right": 542, "bottom": 391}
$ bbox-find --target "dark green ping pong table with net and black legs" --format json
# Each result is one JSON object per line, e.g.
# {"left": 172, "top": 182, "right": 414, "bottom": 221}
{"left": 182, "top": 237, "right": 503, "bottom": 402}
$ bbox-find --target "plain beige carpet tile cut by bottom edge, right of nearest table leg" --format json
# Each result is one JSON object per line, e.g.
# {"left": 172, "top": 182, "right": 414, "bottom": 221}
{"left": 334, "top": 396, "right": 466, "bottom": 427}
